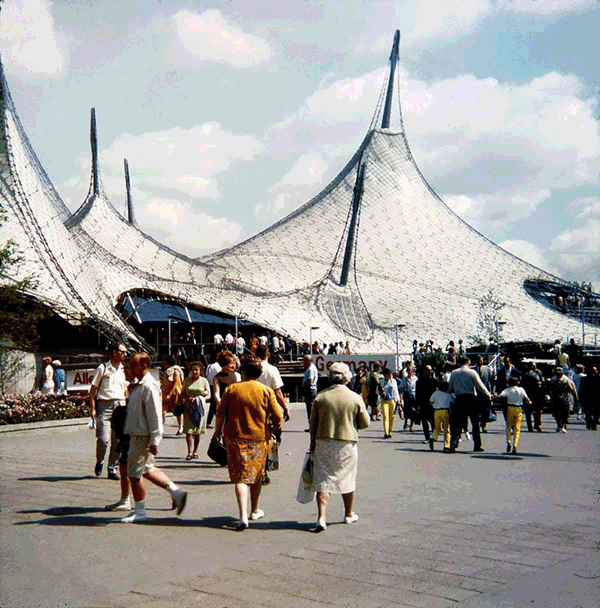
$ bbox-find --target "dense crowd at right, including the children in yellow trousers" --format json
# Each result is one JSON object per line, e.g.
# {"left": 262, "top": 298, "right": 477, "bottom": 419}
{"left": 352, "top": 340, "right": 600, "bottom": 454}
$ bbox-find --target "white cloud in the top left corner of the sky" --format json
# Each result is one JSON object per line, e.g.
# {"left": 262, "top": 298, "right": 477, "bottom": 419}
{"left": 0, "top": 0, "right": 68, "bottom": 76}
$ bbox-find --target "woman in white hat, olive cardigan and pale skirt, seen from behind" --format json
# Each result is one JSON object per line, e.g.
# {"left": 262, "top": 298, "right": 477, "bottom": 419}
{"left": 310, "top": 363, "right": 369, "bottom": 532}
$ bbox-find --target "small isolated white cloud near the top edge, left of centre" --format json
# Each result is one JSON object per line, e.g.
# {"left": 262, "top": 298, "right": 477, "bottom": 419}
{"left": 173, "top": 9, "right": 272, "bottom": 68}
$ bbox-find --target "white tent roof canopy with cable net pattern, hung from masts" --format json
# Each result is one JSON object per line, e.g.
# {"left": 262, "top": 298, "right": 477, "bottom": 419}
{"left": 0, "top": 36, "right": 592, "bottom": 352}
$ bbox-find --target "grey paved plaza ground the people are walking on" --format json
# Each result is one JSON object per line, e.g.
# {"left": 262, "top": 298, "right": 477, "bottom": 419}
{"left": 0, "top": 408, "right": 600, "bottom": 608}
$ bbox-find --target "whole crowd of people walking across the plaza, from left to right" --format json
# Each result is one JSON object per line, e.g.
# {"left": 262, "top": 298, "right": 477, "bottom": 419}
{"left": 54, "top": 332, "right": 600, "bottom": 531}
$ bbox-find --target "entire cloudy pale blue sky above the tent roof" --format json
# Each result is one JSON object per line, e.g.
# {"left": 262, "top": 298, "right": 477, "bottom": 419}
{"left": 0, "top": 0, "right": 600, "bottom": 287}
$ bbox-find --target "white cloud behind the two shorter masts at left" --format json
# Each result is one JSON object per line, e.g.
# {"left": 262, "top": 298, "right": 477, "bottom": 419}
{"left": 61, "top": 122, "right": 263, "bottom": 256}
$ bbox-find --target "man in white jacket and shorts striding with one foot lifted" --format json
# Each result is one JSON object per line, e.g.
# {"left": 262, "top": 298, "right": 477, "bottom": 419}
{"left": 121, "top": 353, "right": 187, "bottom": 523}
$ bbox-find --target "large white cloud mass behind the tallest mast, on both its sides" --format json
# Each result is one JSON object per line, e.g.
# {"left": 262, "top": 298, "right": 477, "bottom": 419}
{"left": 268, "top": 65, "right": 600, "bottom": 232}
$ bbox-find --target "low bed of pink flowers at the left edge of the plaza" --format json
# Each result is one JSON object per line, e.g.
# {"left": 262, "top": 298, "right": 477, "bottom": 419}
{"left": 0, "top": 393, "right": 90, "bottom": 425}
